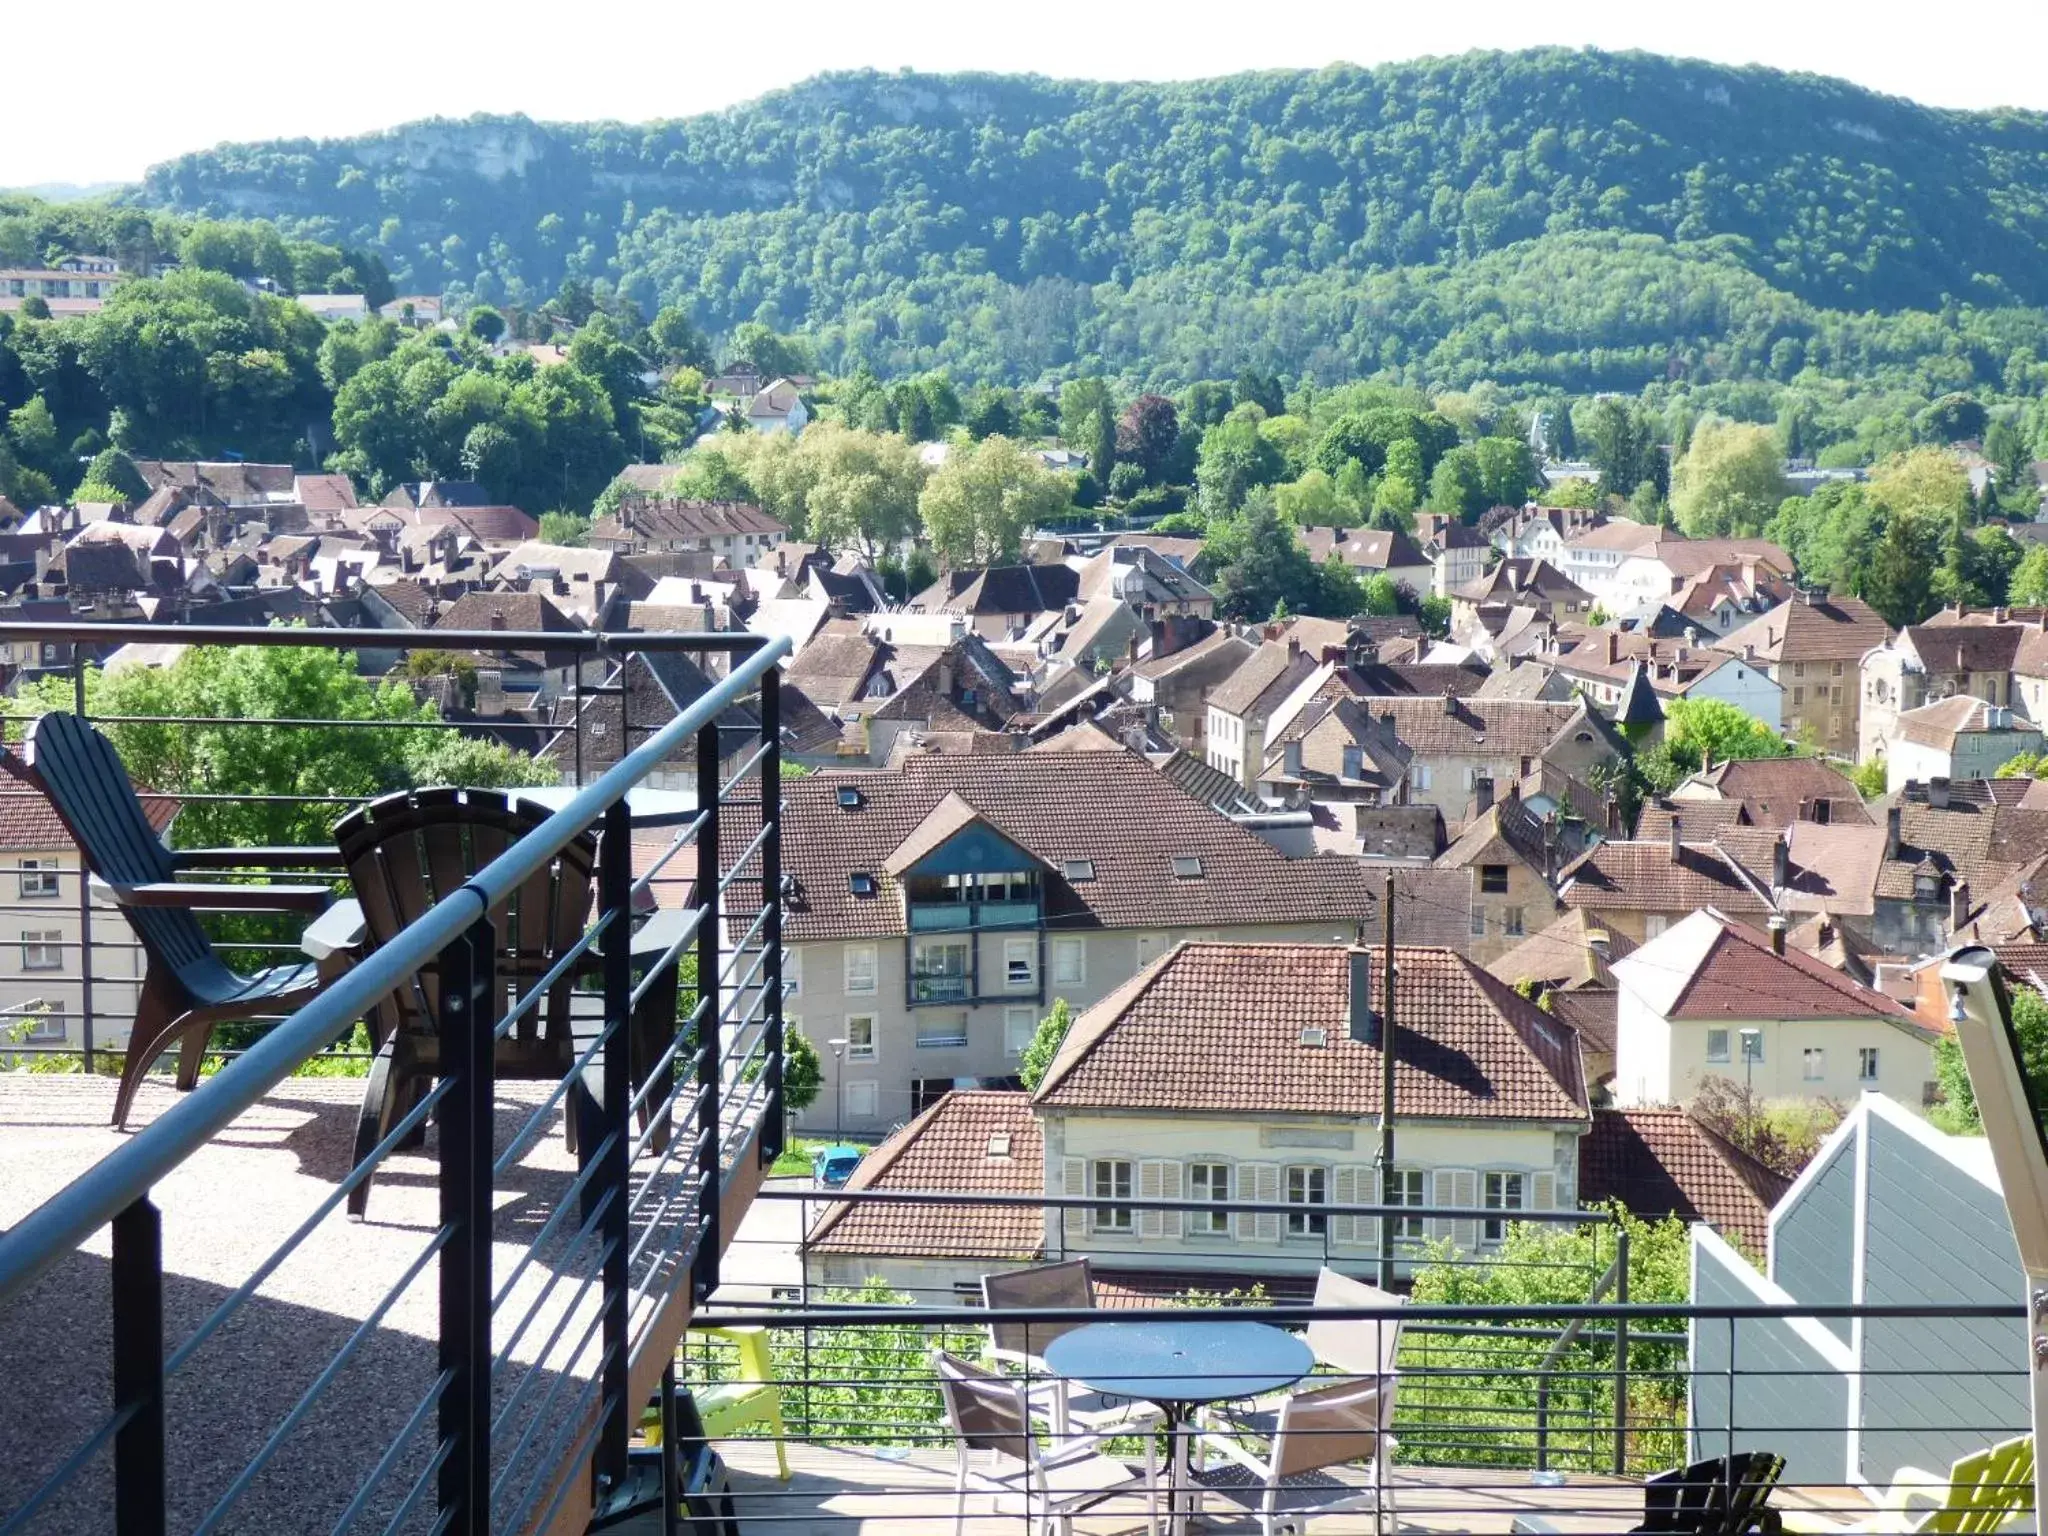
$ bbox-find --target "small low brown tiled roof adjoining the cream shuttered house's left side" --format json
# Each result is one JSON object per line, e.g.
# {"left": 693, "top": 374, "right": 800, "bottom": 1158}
{"left": 807, "top": 1090, "right": 1044, "bottom": 1260}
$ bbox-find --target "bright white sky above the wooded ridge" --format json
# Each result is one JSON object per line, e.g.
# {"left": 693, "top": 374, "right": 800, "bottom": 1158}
{"left": 16, "top": 0, "right": 2048, "bottom": 186}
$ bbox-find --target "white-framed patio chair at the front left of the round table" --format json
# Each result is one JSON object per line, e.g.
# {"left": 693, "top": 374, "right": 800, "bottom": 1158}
{"left": 932, "top": 1350, "right": 1159, "bottom": 1536}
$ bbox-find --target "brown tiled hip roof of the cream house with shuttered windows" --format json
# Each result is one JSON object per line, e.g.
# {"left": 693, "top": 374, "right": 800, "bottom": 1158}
{"left": 1036, "top": 944, "right": 1587, "bottom": 1120}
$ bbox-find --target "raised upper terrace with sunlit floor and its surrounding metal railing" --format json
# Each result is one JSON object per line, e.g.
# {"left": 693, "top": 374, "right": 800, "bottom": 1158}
{"left": 0, "top": 625, "right": 786, "bottom": 1536}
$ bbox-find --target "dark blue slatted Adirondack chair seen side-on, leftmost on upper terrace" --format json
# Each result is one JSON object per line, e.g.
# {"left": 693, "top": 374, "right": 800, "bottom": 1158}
{"left": 4, "top": 713, "right": 348, "bottom": 1126}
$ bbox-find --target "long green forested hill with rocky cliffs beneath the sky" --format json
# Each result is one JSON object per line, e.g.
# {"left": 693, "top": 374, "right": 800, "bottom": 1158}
{"left": 139, "top": 51, "right": 2048, "bottom": 387}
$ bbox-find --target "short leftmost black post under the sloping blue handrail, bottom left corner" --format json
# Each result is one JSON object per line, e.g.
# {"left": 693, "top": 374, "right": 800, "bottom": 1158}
{"left": 109, "top": 1200, "right": 166, "bottom": 1536}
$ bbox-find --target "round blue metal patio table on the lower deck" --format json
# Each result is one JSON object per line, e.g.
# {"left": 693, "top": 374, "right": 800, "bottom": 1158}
{"left": 1044, "top": 1319, "right": 1315, "bottom": 1536}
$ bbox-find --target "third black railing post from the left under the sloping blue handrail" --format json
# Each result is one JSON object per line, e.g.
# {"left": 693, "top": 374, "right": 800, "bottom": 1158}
{"left": 594, "top": 795, "right": 634, "bottom": 1487}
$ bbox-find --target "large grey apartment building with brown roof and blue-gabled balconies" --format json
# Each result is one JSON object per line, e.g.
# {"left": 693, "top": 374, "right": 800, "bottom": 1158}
{"left": 782, "top": 750, "right": 1374, "bottom": 1133}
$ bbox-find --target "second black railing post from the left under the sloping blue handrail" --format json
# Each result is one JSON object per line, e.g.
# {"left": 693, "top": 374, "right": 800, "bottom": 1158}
{"left": 434, "top": 918, "right": 498, "bottom": 1536}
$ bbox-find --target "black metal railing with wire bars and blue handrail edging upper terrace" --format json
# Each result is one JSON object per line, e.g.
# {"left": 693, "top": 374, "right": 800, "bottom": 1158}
{"left": 0, "top": 625, "right": 788, "bottom": 1536}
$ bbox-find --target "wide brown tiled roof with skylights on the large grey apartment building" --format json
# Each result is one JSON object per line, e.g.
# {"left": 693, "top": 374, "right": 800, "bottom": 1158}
{"left": 774, "top": 752, "right": 1378, "bottom": 942}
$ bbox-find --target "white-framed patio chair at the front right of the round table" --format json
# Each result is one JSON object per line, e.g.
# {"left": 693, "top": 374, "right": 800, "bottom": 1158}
{"left": 1188, "top": 1376, "right": 1397, "bottom": 1536}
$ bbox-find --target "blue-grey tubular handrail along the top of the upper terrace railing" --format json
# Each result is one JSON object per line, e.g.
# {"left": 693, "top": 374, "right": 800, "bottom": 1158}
{"left": 0, "top": 625, "right": 791, "bottom": 1305}
